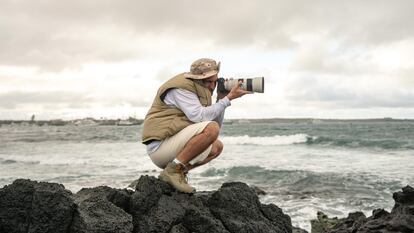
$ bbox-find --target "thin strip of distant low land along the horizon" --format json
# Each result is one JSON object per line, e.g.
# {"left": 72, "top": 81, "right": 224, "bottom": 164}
{"left": 0, "top": 117, "right": 414, "bottom": 126}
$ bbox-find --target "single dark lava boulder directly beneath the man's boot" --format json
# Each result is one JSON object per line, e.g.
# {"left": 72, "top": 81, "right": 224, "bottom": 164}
{"left": 131, "top": 176, "right": 228, "bottom": 232}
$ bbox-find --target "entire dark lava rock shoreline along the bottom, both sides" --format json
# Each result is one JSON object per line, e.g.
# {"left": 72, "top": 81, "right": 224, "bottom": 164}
{"left": 0, "top": 176, "right": 414, "bottom": 233}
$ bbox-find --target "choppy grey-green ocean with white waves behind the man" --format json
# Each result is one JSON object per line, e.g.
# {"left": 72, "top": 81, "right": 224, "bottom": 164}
{"left": 0, "top": 119, "right": 414, "bottom": 230}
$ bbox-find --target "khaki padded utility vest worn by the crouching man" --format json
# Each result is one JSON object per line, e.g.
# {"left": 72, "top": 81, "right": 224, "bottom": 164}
{"left": 142, "top": 73, "right": 211, "bottom": 143}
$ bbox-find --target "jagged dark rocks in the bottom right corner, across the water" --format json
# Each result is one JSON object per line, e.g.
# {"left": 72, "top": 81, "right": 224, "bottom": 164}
{"left": 311, "top": 186, "right": 414, "bottom": 233}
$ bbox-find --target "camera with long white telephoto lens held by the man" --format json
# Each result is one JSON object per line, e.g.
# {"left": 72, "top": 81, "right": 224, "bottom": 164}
{"left": 217, "top": 77, "right": 264, "bottom": 93}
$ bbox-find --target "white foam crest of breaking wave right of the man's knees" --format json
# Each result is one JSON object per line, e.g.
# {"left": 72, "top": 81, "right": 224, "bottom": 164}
{"left": 221, "top": 134, "right": 309, "bottom": 146}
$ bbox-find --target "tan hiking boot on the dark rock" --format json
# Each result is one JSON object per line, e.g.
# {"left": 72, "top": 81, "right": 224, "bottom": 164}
{"left": 158, "top": 162, "right": 195, "bottom": 193}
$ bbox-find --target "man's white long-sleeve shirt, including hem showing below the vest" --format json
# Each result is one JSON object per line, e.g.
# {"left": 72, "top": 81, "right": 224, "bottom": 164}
{"left": 147, "top": 89, "right": 231, "bottom": 154}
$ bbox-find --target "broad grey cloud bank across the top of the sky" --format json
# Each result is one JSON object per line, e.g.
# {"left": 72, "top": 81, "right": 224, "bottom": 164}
{"left": 0, "top": 0, "right": 414, "bottom": 69}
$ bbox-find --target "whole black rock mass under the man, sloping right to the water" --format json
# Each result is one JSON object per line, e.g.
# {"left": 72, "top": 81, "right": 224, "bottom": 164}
{"left": 130, "top": 176, "right": 292, "bottom": 233}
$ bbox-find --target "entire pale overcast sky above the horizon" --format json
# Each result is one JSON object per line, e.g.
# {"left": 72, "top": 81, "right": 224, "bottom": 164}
{"left": 0, "top": 0, "right": 414, "bottom": 119}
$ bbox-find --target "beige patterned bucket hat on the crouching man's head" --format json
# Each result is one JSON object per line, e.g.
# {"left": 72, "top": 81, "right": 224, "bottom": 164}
{"left": 184, "top": 58, "right": 220, "bottom": 79}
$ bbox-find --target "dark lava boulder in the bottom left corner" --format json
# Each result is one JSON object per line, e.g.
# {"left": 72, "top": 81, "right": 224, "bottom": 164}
{"left": 0, "top": 179, "right": 76, "bottom": 233}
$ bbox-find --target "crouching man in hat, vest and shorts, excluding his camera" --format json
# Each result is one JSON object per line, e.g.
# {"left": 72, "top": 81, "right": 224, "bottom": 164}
{"left": 142, "top": 58, "right": 250, "bottom": 193}
